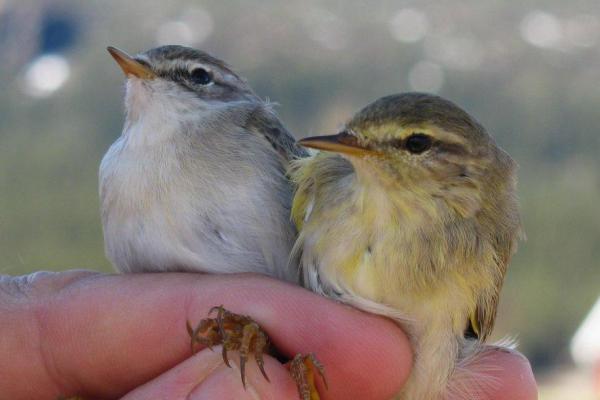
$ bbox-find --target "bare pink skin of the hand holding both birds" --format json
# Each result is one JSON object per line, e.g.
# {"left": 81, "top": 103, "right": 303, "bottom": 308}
{"left": 0, "top": 271, "right": 537, "bottom": 400}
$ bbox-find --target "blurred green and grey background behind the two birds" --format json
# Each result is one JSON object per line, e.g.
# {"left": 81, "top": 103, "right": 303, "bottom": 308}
{"left": 0, "top": 0, "right": 600, "bottom": 400}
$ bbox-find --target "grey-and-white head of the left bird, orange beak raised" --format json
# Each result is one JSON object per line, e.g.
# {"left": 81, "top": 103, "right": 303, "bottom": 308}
{"left": 108, "top": 45, "right": 258, "bottom": 124}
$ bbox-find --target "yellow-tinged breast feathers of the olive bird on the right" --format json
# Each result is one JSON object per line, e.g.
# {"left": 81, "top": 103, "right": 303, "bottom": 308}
{"left": 293, "top": 153, "right": 495, "bottom": 332}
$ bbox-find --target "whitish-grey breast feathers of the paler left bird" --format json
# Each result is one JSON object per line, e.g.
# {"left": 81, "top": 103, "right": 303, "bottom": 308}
{"left": 100, "top": 139, "right": 294, "bottom": 280}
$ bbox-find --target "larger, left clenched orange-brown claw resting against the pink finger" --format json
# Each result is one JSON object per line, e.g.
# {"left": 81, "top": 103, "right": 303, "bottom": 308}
{"left": 186, "top": 306, "right": 270, "bottom": 388}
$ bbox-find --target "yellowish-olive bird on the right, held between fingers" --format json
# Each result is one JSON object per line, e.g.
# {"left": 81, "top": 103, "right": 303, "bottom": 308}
{"left": 290, "top": 92, "right": 522, "bottom": 400}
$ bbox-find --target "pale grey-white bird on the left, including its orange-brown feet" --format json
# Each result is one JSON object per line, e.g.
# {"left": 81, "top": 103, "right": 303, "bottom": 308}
{"left": 99, "top": 45, "right": 324, "bottom": 398}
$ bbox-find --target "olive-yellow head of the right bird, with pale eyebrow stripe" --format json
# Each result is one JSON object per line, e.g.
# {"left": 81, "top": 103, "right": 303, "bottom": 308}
{"left": 300, "top": 93, "right": 515, "bottom": 217}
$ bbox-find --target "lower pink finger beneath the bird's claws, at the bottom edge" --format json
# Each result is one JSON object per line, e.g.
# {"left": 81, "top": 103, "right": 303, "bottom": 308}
{"left": 123, "top": 347, "right": 297, "bottom": 400}
